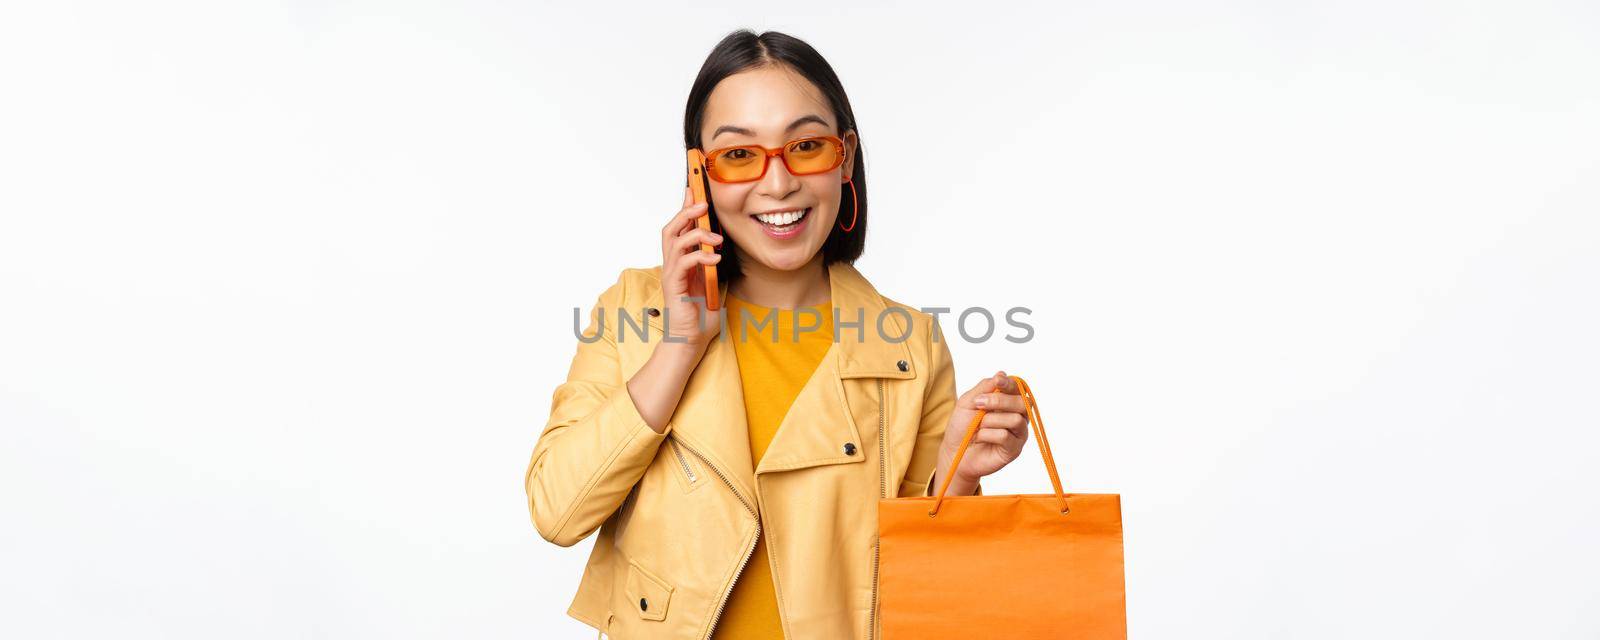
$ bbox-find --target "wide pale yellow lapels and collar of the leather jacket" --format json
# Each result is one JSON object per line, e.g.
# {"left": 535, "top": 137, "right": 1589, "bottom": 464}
{"left": 646, "top": 262, "right": 917, "bottom": 504}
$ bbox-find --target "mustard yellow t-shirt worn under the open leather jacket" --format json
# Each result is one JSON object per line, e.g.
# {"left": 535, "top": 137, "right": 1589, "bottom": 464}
{"left": 714, "top": 294, "right": 834, "bottom": 640}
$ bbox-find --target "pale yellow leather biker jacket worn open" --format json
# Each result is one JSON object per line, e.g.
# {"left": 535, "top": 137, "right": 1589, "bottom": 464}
{"left": 526, "top": 264, "right": 955, "bottom": 640}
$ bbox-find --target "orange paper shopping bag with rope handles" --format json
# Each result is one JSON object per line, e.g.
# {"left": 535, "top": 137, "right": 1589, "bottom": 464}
{"left": 878, "top": 376, "right": 1128, "bottom": 640}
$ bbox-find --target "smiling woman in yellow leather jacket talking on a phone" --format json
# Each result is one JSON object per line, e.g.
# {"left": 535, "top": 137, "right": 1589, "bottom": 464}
{"left": 526, "top": 30, "right": 1027, "bottom": 640}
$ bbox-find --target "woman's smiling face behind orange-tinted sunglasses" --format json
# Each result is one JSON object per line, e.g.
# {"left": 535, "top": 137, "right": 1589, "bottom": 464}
{"left": 701, "top": 66, "right": 856, "bottom": 270}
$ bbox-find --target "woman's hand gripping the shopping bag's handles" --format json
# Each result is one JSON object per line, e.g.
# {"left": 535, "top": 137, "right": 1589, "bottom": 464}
{"left": 933, "top": 371, "right": 1027, "bottom": 496}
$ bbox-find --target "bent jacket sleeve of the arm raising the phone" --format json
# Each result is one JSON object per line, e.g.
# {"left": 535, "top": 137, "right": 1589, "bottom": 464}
{"left": 525, "top": 272, "right": 672, "bottom": 547}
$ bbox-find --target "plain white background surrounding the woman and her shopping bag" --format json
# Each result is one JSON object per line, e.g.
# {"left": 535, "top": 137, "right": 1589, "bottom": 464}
{"left": 0, "top": 2, "right": 1600, "bottom": 638}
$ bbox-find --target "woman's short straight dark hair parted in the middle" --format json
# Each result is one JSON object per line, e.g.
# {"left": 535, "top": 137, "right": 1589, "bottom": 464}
{"left": 683, "top": 29, "right": 867, "bottom": 282}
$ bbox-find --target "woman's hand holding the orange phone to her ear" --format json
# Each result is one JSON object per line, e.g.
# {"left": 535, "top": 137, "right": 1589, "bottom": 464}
{"left": 661, "top": 187, "right": 722, "bottom": 347}
